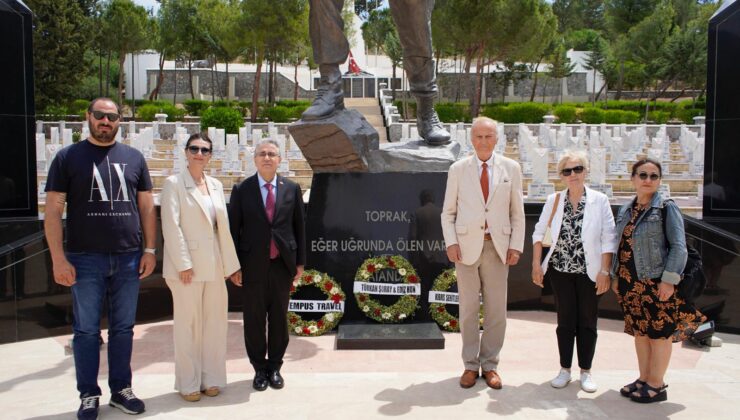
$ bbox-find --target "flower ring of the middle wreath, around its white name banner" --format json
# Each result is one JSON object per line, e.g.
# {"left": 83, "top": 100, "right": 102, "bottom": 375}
{"left": 355, "top": 255, "right": 420, "bottom": 323}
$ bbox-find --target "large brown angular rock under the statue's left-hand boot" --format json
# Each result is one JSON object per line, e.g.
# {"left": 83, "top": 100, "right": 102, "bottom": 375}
{"left": 288, "top": 110, "right": 379, "bottom": 173}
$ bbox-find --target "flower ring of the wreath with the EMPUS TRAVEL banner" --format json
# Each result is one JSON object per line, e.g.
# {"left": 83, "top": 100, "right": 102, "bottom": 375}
{"left": 288, "top": 270, "right": 346, "bottom": 337}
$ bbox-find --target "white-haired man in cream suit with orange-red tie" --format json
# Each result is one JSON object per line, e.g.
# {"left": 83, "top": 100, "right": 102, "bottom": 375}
{"left": 442, "top": 117, "right": 525, "bottom": 389}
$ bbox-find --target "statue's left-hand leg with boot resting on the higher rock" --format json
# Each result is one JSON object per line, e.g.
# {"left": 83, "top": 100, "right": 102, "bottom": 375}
{"left": 302, "top": 0, "right": 349, "bottom": 121}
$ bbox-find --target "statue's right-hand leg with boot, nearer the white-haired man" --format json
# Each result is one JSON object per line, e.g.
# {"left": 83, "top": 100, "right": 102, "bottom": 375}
{"left": 390, "top": 0, "right": 450, "bottom": 145}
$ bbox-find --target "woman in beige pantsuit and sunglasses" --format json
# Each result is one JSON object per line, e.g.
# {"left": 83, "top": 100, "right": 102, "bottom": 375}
{"left": 161, "top": 134, "right": 239, "bottom": 401}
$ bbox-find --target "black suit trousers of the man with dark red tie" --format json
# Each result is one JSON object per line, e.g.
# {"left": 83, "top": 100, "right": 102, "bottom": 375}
{"left": 242, "top": 258, "right": 293, "bottom": 371}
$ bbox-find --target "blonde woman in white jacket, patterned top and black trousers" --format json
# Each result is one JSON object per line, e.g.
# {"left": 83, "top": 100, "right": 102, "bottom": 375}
{"left": 532, "top": 151, "right": 617, "bottom": 392}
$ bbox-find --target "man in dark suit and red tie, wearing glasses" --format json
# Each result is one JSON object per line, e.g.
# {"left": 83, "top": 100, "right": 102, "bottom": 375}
{"left": 229, "top": 140, "right": 306, "bottom": 391}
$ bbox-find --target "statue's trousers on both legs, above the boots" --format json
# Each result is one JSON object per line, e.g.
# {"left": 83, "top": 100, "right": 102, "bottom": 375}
{"left": 309, "top": 0, "right": 437, "bottom": 96}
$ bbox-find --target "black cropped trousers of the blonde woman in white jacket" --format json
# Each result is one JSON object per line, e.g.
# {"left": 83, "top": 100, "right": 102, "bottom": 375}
{"left": 546, "top": 266, "right": 601, "bottom": 370}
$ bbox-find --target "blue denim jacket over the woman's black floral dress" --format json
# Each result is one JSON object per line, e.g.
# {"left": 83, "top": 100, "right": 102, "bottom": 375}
{"left": 611, "top": 193, "right": 688, "bottom": 285}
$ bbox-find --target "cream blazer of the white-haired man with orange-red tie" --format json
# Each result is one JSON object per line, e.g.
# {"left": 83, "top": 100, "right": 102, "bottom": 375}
{"left": 442, "top": 153, "right": 525, "bottom": 265}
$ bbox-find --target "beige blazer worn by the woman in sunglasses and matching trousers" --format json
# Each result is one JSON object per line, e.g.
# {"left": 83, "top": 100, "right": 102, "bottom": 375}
{"left": 160, "top": 170, "right": 239, "bottom": 281}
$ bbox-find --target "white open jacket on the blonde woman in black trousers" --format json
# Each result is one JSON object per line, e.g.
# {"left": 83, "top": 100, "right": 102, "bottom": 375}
{"left": 532, "top": 187, "right": 617, "bottom": 282}
